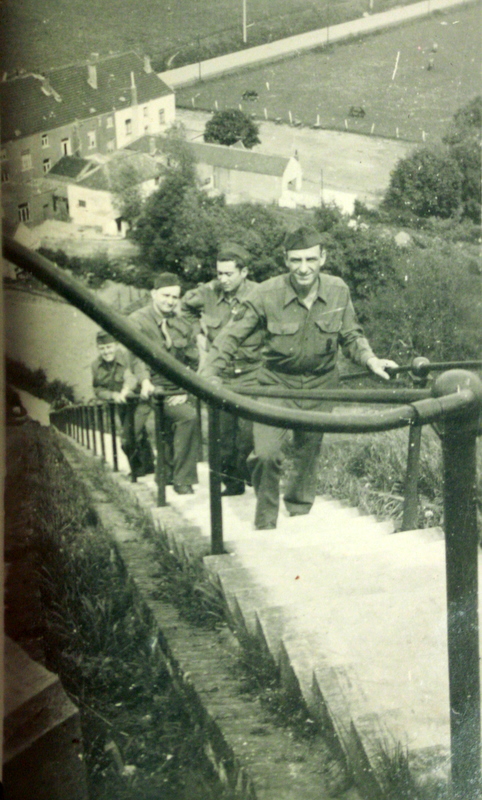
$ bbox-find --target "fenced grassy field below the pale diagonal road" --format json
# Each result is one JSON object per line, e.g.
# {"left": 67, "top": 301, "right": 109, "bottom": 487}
{"left": 176, "top": 4, "right": 482, "bottom": 143}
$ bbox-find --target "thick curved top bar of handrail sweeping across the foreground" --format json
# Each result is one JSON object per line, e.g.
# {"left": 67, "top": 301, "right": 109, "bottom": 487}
{"left": 3, "top": 237, "right": 471, "bottom": 433}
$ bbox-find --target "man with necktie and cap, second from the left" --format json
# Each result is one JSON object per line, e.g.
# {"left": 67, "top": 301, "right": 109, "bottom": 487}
{"left": 129, "top": 272, "right": 200, "bottom": 494}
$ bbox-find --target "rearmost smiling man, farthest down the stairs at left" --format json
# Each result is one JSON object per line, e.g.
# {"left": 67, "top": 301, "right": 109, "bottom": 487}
{"left": 92, "top": 331, "right": 154, "bottom": 476}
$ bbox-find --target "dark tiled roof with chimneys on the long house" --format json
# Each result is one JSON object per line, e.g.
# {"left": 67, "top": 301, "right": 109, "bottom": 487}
{"left": 0, "top": 53, "right": 172, "bottom": 142}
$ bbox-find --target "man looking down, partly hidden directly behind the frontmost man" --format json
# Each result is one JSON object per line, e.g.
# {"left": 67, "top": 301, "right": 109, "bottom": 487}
{"left": 181, "top": 242, "right": 264, "bottom": 495}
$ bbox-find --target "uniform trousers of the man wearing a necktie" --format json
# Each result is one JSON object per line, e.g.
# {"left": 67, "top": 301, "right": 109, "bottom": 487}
{"left": 129, "top": 400, "right": 200, "bottom": 486}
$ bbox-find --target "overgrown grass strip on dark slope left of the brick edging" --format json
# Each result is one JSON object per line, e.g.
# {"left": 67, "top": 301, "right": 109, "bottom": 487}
{"left": 6, "top": 428, "right": 230, "bottom": 800}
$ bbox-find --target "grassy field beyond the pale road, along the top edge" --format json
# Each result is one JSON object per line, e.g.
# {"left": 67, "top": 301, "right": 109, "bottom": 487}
{"left": 0, "top": 0, "right": 413, "bottom": 71}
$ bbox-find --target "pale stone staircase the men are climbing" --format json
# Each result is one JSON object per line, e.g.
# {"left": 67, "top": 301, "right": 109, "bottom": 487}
{"left": 153, "top": 464, "right": 482, "bottom": 800}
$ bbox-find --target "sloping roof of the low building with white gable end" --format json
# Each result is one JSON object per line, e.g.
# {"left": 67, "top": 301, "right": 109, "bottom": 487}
{"left": 189, "top": 142, "right": 289, "bottom": 177}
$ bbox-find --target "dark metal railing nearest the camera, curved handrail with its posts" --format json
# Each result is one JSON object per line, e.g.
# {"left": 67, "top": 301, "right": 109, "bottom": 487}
{"left": 4, "top": 239, "right": 482, "bottom": 800}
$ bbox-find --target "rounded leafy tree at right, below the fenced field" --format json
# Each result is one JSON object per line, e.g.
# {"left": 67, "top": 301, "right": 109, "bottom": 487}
{"left": 383, "top": 147, "right": 462, "bottom": 218}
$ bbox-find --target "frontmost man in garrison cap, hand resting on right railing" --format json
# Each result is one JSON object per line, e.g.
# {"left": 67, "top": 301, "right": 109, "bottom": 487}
{"left": 201, "top": 226, "right": 396, "bottom": 529}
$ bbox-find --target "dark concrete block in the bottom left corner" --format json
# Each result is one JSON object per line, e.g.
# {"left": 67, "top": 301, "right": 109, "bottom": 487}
{"left": 3, "top": 637, "right": 88, "bottom": 800}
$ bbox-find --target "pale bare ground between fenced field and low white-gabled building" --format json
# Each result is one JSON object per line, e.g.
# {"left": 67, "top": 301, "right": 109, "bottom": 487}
{"left": 176, "top": 109, "right": 414, "bottom": 204}
